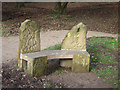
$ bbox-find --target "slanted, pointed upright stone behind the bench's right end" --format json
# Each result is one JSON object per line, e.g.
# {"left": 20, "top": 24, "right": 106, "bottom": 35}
{"left": 61, "top": 22, "right": 87, "bottom": 51}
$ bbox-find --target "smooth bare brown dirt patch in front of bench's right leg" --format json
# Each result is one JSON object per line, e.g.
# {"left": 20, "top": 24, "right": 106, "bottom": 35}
{"left": 47, "top": 71, "right": 113, "bottom": 88}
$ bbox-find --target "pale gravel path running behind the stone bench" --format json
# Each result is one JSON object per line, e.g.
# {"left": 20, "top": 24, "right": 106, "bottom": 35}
{"left": 0, "top": 30, "right": 117, "bottom": 63}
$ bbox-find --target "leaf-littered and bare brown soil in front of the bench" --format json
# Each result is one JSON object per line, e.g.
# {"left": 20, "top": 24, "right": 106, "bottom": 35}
{"left": 2, "top": 61, "right": 114, "bottom": 88}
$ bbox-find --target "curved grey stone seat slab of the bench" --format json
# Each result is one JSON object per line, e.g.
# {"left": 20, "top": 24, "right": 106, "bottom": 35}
{"left": 21, "top": 50, "right": 88, "bottom": 60}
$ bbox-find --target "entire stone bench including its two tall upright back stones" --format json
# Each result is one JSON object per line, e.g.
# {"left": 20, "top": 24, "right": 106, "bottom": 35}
{"left": 18, "top": 20, "right": 90, "bottom": 76}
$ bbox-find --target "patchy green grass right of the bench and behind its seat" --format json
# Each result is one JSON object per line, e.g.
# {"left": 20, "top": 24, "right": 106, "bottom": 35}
{"left": 45, "top": 37, "right": 120, "bottom": 87}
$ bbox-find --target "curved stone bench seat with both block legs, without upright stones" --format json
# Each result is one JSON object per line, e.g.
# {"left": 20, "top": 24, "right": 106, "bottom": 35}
{"left": 20, "top": 50, "right": 90, "bottom": 76}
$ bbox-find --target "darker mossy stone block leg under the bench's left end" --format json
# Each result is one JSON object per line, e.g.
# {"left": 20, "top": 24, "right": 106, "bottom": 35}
{"left": 22, "top": 56, "right": 47, "bottom": 77}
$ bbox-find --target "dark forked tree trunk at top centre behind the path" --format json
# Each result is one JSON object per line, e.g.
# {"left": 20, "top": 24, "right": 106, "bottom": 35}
{"left": 54, "top": 2, "right": 68, "bottom": 14}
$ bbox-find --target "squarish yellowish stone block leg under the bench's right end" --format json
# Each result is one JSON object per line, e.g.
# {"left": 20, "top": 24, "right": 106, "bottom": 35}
{"left": 72, "top": 54, "right": 90, "bottom": 72}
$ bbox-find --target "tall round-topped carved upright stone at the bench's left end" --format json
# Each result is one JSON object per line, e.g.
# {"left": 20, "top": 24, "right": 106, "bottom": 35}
{"left": 18, "top": 20, "right": 40, "bottom": 68}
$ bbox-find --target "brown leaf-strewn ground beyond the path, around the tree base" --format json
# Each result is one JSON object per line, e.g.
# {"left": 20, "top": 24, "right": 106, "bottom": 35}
{"left": 2, "top": 2, "right": 118, "bottom": 35}
